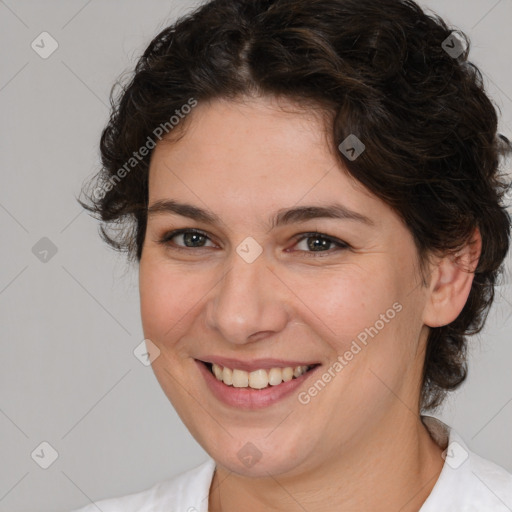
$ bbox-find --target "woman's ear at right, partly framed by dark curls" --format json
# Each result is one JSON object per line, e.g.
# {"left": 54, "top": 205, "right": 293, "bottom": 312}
{"left": 423, "top": 228, "right": 482, "bottom": 327}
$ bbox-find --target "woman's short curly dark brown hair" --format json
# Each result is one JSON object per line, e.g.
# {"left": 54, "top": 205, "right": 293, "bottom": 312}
{"left": 79, "top": 0, "right": 510, "bottom": 410}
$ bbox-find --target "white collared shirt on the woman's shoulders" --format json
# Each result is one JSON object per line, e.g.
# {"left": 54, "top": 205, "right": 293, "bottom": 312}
{"left": 74, "top": 416, "right": 512, "bottom": 512}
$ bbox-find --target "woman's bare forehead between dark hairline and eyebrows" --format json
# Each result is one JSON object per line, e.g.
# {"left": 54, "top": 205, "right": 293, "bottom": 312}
{"left": 149, "top": 98, "right": 392, "bottom": 230}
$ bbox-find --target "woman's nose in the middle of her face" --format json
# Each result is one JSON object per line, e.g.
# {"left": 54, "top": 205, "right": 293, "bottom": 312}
{"left": 206, "top": 247, "right": 288, "bottom": 345}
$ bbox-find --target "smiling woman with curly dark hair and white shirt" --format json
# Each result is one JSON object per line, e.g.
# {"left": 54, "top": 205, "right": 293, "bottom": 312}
{"left": 74, "top": 0, "right": 512, "bottom": 512}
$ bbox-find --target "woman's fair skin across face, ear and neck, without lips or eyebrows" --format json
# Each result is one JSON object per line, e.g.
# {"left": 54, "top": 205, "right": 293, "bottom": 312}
{"left": 139, "top": 97, "right": 481, "bottom": 512}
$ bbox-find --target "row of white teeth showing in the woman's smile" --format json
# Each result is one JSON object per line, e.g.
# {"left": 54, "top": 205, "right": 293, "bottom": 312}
{"left": 212, "top": 363, "right": 310, "bottom": 389}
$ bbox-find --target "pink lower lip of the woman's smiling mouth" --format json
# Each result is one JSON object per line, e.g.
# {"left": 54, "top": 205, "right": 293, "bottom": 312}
{"left": 196, "top": 360, "right": 319, "bottom": 409}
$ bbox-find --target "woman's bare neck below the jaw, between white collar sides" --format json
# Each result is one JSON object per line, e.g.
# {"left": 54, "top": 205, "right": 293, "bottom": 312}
{"left": 208, "top": 410, "right": 443, "bottom": 512}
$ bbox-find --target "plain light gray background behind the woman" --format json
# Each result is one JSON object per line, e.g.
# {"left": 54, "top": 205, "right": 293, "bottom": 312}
{"left": 0, "top": 0, "right": 512, "bottom": 512}
